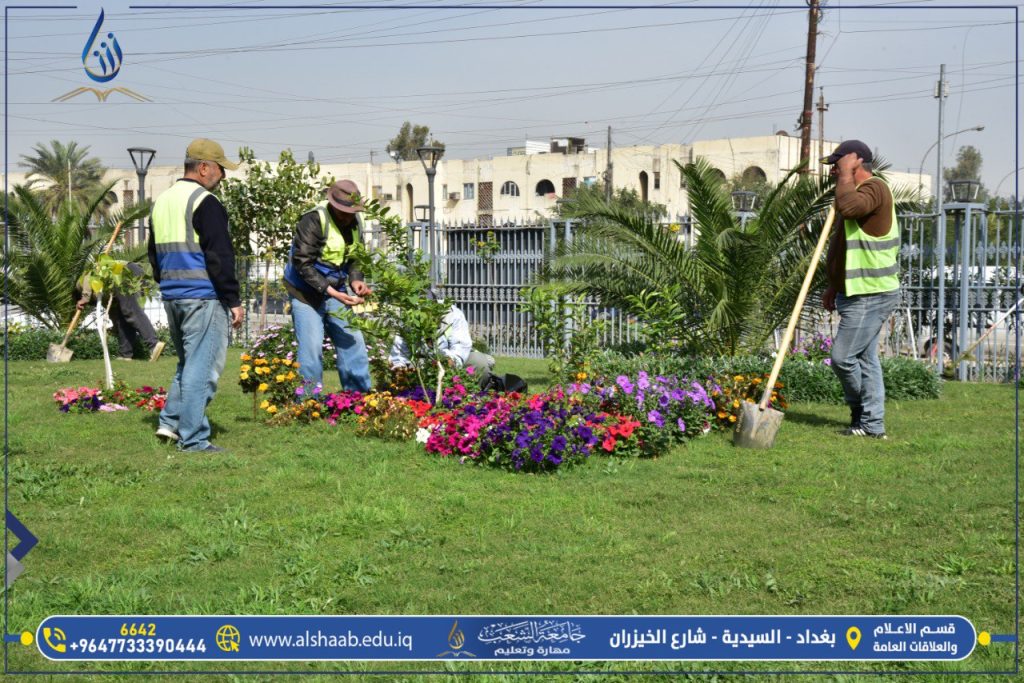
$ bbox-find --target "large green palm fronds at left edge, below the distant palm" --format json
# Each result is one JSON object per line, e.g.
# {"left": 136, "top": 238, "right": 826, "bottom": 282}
{"left": 4, "top": 183, "right": 150, "bottom": 330}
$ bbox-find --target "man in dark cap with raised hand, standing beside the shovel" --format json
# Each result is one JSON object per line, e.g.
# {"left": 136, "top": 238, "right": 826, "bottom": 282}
{"left": 821, "top": 140, "right": 900, "bottom": 439}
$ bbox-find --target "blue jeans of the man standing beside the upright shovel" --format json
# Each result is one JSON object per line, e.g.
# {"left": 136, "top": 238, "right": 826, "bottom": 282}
{"left": 831, "top": 291, "right": 899, "bottom": 434}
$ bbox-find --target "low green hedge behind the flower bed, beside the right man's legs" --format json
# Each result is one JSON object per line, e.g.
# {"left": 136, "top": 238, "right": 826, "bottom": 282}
{"left": 593, "top": 351, "right": 941, "bottom": 403}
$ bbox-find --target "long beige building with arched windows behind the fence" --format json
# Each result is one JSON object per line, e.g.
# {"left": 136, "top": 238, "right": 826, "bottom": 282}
{"left": 2, "top": 134, "right": 932, "bottom": 225}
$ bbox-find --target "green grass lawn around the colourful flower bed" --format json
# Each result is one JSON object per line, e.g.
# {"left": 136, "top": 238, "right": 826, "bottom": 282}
{"left": 7, "top": 351, "right": 1016, "bottom": 681}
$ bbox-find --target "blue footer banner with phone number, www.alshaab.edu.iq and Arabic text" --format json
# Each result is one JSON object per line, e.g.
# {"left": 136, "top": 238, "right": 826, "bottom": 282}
{"left": 36, "top": 614, "right": 977, "bottom": 661}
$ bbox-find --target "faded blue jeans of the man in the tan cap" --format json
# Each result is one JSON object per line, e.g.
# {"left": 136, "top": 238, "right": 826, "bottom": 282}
{"left": 160, "top": 299, "right": 230, "bottom": 451}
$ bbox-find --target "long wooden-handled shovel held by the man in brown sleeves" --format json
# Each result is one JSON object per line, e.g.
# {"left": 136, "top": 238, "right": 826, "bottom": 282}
{"left": 732, "top": 206, "right": 836, "bottom": 449}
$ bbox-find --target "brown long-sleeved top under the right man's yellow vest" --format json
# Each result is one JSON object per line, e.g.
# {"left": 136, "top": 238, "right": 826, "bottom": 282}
{"left": 825, "top": 176, "right": 893, "bottom": 294}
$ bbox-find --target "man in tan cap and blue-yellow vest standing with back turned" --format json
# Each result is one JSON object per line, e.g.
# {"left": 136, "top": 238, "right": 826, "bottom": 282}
{"left": 148, "top": 138, "right": 244, "bottom": 453}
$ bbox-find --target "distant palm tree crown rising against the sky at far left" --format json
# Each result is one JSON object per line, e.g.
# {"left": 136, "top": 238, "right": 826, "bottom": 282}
{"left": 19, "top": 140, "right": 111, "bottom": 215}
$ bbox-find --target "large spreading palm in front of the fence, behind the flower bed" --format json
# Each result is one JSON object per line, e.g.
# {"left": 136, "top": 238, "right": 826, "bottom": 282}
{"left": 545, "top": 159, "right": 907, "bottom": 355}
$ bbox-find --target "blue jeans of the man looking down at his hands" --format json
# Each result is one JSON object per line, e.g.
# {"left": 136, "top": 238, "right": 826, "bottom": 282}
{"left": 292, "top": 297, "right": 370, "bottom": 392}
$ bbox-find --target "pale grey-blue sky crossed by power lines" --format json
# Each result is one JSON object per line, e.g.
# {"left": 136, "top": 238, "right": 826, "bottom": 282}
{"left": 4, "top": 0, "right": 1021, "bottom": 196}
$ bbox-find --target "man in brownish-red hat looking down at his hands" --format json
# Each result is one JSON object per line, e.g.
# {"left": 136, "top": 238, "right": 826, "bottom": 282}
{"left": 285, "top": 180, "right": 373, "bottom": 391}
